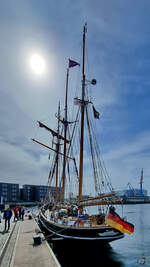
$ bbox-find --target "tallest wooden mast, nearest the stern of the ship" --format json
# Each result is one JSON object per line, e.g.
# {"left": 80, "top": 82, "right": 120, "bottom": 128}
{"left": 78, "top": 24, "right": 87, "bottom": 204}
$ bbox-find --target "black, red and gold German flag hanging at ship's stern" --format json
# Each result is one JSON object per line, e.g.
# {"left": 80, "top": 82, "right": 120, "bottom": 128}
{"left": 105, "top": 208, "right": 134, "bottom": 234}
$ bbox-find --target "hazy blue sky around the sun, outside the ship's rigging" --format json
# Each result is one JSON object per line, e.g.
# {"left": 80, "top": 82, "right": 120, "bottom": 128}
{"left": 0, "top": 0, "right": 150, "bottom": 194}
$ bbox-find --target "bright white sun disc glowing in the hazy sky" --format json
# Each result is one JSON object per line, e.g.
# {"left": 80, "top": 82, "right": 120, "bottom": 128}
{"left": 30, "top": 54, "right": 46, "bottom": 75}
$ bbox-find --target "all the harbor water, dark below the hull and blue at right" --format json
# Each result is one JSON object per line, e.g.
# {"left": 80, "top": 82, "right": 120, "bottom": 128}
{"left": 53, "top": 204, "right": 150, "bottom": 267}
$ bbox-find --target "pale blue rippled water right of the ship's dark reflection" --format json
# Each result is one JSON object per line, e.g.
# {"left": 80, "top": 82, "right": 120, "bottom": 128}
{"left": 112, "top": 204, "right": 150, "bottom": 267}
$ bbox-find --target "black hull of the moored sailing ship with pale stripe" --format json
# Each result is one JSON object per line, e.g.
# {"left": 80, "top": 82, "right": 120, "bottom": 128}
{"left": 39, "top": 213, "right": 124, "bottom": 243}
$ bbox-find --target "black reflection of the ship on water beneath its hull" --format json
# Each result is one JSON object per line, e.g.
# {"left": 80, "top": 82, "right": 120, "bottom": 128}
{"left": 53, "top": 241, "right": 124, "bottom": 267}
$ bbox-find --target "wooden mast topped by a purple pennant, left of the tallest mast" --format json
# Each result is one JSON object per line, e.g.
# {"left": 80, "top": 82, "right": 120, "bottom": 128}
{"left": 62, "top": 68, "right": 69, "bottom": 203}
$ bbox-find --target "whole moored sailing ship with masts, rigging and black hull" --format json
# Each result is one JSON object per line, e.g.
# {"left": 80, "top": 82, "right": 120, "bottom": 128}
{"left": 32, "top": 24, "right": 133, "bottom": 243}
